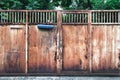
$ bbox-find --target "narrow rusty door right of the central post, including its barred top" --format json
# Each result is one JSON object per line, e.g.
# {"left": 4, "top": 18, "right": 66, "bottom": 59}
{"left": 62, "top": 11, "right": 90, "bottom": 72}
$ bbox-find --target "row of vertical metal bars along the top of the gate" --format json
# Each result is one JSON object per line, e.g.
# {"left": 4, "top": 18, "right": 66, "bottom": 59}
{"left": 0, "top": 10, "right": 120, "bottom": 24}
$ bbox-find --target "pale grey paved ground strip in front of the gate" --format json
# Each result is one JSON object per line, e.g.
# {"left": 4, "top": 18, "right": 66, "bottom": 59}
{"left": 0, "top": 77, "right": 120, "bottom": 80}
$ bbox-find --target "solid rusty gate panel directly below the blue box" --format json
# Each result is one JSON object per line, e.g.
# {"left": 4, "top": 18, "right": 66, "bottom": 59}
{"left": 28, "top": 25, "right": 56, "bottom": 73}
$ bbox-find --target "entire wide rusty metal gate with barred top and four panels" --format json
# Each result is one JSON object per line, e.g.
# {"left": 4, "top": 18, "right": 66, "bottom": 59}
{"left": 0, "top": 10, "right": 120, "bottom": 75}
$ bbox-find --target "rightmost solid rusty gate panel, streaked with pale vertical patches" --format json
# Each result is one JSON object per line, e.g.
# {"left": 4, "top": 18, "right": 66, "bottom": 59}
{"left": 92, "top": 25, "right": 118, "bottom": 72}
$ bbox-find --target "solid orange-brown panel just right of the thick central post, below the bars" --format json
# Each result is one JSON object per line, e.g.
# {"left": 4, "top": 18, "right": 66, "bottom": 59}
{"left": 62, "top": 25, "right": 89, "bottom": 71}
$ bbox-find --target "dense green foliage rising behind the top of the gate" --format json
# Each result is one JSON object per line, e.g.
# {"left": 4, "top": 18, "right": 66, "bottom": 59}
{"left": 0, "top": 0, "right": 120, "bottom": 10}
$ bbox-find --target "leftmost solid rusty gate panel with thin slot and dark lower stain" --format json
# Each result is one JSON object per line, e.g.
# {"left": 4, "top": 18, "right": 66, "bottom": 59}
{"left": 0, "top": 25, "right": 25, "bottom": 73}
